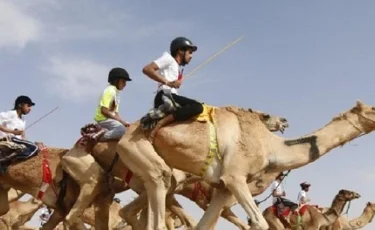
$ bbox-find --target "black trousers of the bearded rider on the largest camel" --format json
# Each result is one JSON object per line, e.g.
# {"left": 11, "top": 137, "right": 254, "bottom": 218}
{"left": 154, "top": 90, "right": 203, "bottom": 121}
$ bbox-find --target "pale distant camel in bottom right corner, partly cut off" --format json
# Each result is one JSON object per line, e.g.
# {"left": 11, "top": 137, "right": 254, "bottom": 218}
{"left": 320, "top": 202, "right": 375, "bottom": 230}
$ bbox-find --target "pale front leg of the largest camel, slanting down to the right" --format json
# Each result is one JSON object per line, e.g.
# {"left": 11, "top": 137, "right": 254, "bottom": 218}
{"left": 220, "top": 175, "right": 269, "bottom": 230}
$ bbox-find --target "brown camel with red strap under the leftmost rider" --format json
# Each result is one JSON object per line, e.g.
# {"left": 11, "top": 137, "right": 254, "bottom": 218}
{"left": 0, "top": 148, "right": 92, "bottom": 229}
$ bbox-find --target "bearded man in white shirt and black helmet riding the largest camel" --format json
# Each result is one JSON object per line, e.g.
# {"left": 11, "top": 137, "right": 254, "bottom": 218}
{"left": 143, "top": 37, "right": 203, "bottom": 142}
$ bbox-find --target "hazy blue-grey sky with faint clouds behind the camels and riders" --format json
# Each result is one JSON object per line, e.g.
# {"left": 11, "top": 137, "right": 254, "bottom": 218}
{"left": 0, "top": 0, "right": 375, "bottom": 230}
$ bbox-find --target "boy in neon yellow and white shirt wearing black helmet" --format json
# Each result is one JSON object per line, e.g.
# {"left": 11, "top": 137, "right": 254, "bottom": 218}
{"left": 94, "top": 67, "right": 132, "bottom": 141}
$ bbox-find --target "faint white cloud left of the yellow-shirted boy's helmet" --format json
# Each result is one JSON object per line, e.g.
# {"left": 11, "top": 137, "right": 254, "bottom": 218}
{"left": 42, "top": 56, "right": 110, "bottom": 102}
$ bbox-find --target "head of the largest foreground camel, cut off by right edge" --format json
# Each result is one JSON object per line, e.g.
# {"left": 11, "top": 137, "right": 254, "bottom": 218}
{"left": 343, "top": 101, "right": 375, "bottom": 133}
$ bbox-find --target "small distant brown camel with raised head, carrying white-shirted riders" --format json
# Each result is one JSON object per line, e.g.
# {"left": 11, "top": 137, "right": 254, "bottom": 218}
{"left": 263, "top": 189, "right": 360, "bottom": 230}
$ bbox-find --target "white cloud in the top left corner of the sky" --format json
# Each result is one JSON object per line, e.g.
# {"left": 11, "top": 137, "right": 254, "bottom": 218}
{"left": 0, "top": 0, "right": 40, "bottom": 48}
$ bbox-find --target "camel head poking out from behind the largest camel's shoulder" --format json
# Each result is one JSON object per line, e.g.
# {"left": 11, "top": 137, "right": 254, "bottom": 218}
{"left": 248, "top": 109, "right": 289, "bottom": 133}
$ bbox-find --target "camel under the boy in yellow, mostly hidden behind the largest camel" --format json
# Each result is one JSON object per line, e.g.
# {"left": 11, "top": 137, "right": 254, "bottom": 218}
{"left": 62, "top": 110, "right": 288, "bottom": 229}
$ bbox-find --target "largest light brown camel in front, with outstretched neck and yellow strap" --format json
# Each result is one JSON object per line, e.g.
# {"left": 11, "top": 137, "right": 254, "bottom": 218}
{"left": 117, "top": 101, "right": 375, "bottom": 230}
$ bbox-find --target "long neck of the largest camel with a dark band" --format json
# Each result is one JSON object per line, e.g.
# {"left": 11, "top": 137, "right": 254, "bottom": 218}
{"left": 268, "top": 118, "right": 361, "bottom": 171}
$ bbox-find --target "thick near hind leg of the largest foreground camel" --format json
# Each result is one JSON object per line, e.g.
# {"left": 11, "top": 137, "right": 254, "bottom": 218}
{"left": 117, "top": 133, "right": 172, "bottom": 230}
